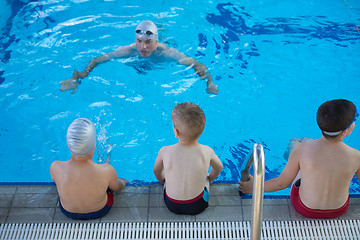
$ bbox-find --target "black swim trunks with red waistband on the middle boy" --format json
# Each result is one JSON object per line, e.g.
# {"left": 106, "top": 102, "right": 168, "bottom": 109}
{"left": 164, "top": 187, "right": 209, "bottom": 215}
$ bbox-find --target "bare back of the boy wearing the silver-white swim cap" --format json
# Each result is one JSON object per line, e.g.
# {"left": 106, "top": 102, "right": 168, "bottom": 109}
{"left": 50, "top": 160, "right": 112, "bottom": 213}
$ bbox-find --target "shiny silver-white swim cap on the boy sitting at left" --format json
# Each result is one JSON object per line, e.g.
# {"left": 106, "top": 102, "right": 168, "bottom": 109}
{"left": 66, "top": 118, "right": 96, "bottom": 157}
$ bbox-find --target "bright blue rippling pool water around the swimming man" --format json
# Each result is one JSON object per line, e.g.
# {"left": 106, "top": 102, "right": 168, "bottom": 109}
{"left": 0, "top": 0, "right": 360, "bottom": 195}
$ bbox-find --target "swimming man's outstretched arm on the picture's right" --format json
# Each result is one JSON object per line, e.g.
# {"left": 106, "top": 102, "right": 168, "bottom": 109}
{"left": 164, "top": 48, "right": 219, "bottom": 94}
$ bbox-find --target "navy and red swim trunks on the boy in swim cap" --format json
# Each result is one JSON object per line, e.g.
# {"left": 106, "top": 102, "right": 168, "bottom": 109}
{"left": 59, "top": 188, "right": 114, "bottom": 220}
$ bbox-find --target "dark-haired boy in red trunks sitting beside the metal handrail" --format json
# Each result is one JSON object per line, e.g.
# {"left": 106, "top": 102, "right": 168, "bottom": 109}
{"left": 239, "top": 99, "right": 360, "bottom": 219}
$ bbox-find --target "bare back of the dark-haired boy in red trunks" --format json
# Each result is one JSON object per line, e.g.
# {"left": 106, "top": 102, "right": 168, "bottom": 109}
{"left": 297, "top": 140, "right": 360, "bottom": 209}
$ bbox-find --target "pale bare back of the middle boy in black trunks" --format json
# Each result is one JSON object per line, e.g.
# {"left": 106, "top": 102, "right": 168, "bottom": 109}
{"left": 159, "top": 143, "right": 221, "bottom": 200}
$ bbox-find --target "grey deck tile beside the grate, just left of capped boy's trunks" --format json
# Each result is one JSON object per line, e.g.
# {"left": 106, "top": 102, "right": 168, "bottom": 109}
{"left": 6, "top": 208, "right": 55, "bottom": 223}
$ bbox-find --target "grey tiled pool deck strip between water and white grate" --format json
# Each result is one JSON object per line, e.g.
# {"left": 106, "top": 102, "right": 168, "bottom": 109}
{"left": 0, "top": 184, "right": 360, "bottom": 224}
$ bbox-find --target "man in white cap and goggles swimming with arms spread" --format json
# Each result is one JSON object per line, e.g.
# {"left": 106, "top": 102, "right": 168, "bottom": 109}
{"left": 60, "top": 20, "right": 219, "bottom": 94}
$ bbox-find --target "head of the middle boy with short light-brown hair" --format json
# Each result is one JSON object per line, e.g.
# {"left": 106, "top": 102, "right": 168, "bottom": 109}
{"left": 172, "top": 102, "right": 205, "bottom": 141}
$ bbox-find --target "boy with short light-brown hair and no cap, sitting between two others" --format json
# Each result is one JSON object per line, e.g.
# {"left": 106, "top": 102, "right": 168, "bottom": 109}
{"left": 154, "top": 102, "right": 223, "bottom": 215}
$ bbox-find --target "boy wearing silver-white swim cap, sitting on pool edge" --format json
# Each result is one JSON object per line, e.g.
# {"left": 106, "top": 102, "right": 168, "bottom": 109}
{"left": 50, "top": 118, "right": 126, "bottom": 220}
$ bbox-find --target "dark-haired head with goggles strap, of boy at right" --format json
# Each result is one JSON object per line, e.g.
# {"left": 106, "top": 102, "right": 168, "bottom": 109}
{"left": 316, "top": 99, "right": 358, "bottom": 138}
